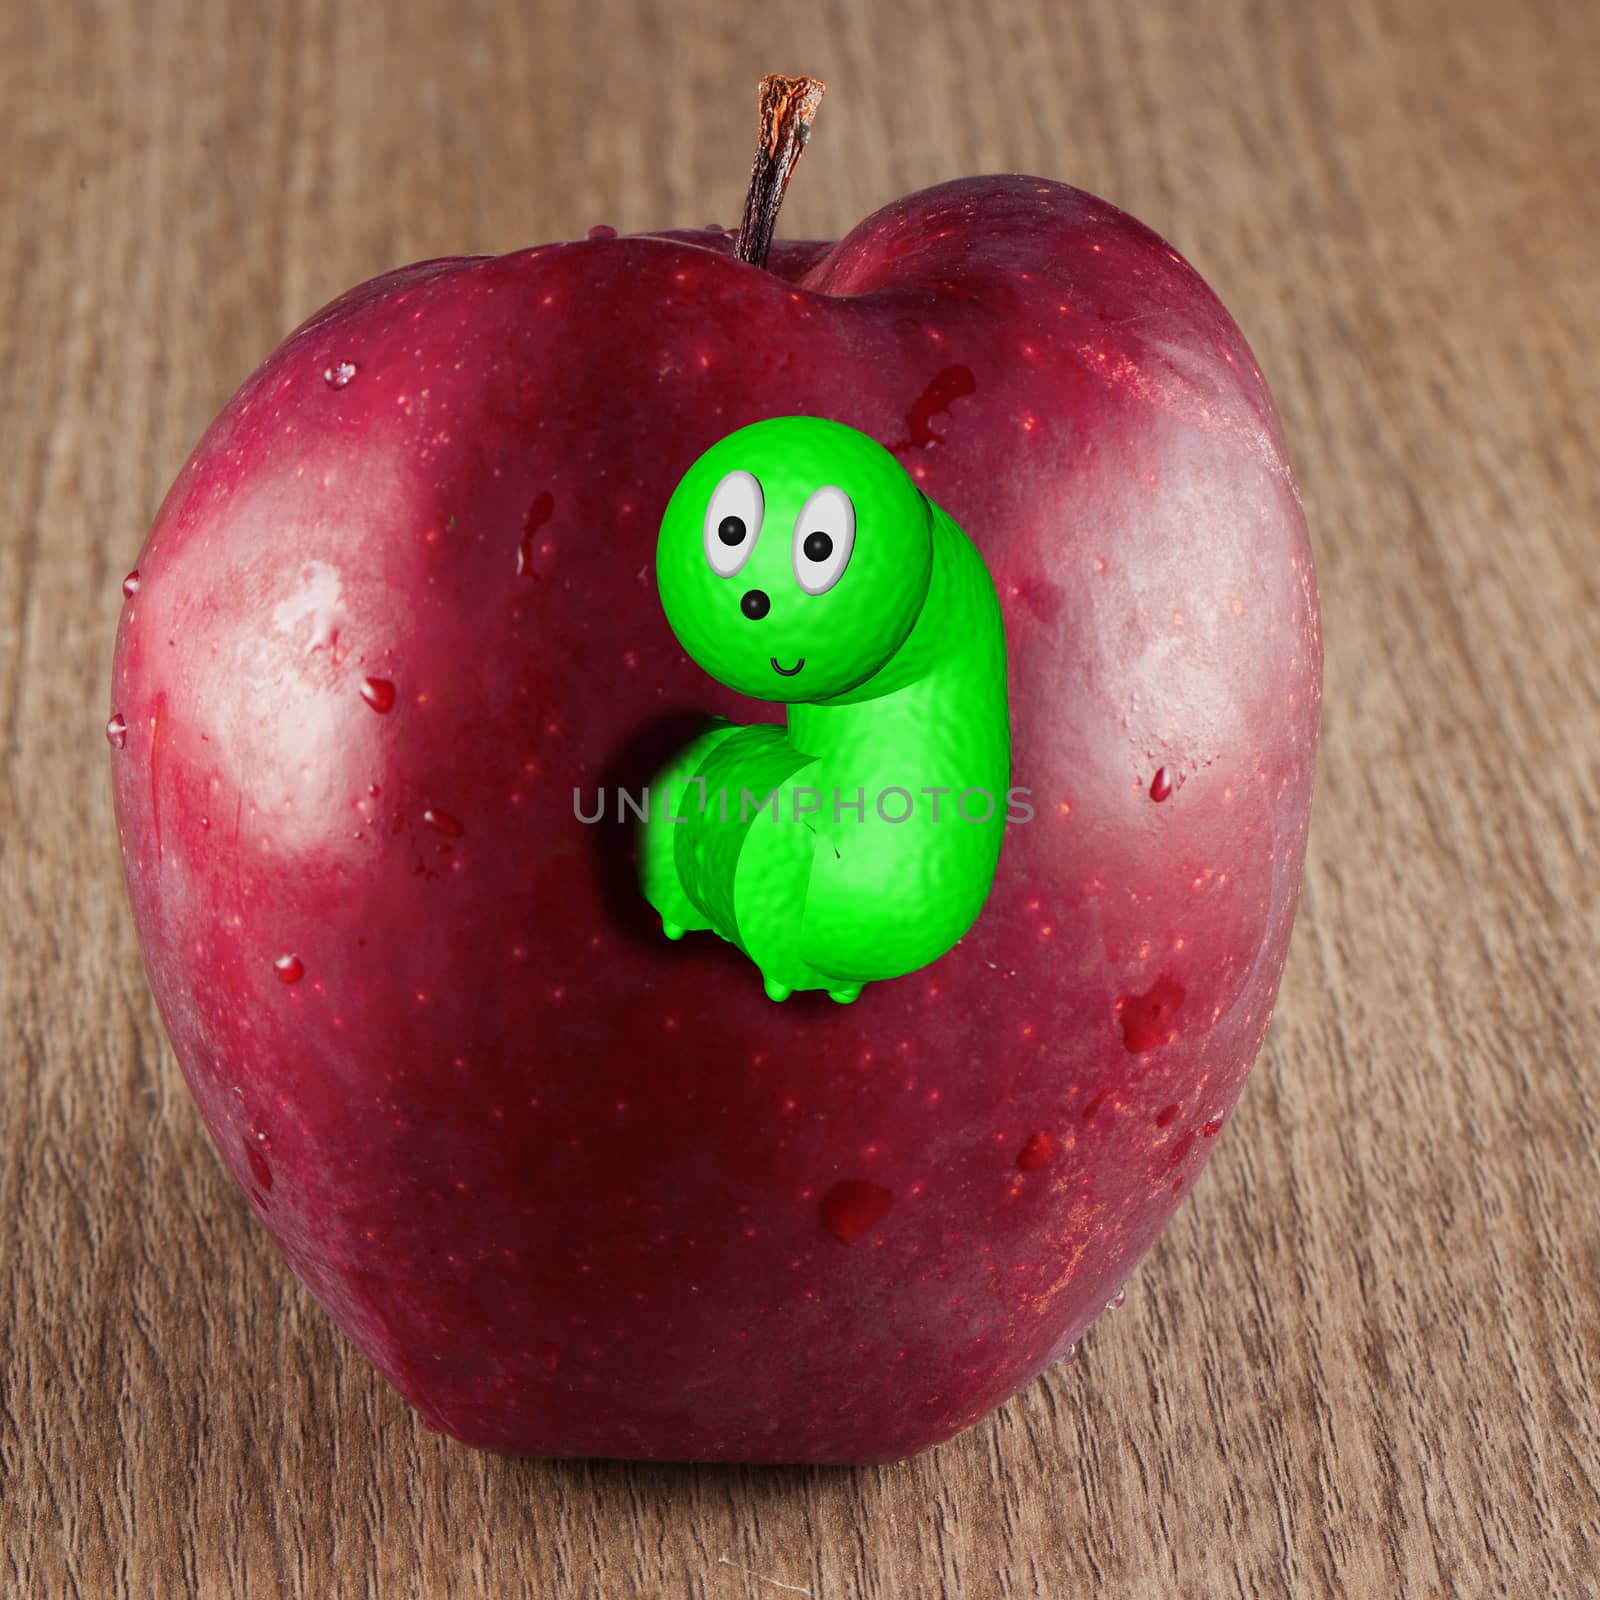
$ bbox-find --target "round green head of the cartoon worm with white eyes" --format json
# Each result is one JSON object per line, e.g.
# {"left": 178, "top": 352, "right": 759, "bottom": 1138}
{"left": 656, "top": 416, "right": 933, "bottom": 702}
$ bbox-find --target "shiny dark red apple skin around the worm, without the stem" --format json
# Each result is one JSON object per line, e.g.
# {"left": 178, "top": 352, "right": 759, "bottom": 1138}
{"left": 110, "top": 174, "right": 1322, "bottom": 1462}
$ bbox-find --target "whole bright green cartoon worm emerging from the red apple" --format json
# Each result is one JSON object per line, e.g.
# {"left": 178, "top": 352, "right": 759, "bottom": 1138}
{"left": 640, "top": 416, "right": 1011, "bottom": 1002}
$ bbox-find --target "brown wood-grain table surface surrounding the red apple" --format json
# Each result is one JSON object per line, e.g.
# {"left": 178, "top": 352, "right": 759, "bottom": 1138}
{"left": 0, "top": 0, "right": 1600, "bottom": 1600}
